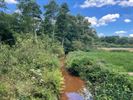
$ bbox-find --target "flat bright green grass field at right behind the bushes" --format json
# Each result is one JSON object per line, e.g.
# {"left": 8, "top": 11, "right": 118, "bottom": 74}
{"left": 88, "top": 51, "right": 133, "bottom": 72}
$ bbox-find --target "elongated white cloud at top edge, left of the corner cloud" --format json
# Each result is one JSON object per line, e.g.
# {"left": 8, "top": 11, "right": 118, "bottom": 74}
{"left": 80, "top": 0, "right": 116, "bottom": 8}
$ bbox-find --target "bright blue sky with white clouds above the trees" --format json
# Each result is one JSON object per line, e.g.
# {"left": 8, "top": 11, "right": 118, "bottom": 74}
{"left": 5, "top": 0, "right": 133, "bottom": 37}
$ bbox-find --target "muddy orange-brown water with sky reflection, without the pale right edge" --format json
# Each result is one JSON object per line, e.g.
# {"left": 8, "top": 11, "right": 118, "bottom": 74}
{"left": 60, "top": 58, "right": 85, "bottom": 100}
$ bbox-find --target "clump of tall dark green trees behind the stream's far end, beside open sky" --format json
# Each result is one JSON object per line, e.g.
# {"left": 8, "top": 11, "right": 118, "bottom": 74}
{"left": 42, "top": 0, "right": 97, "bottom": 53}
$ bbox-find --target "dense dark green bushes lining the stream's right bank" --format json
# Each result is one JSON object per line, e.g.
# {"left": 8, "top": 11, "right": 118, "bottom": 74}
{"left": 67, "top": 51, "right": 133, "bottom": 100}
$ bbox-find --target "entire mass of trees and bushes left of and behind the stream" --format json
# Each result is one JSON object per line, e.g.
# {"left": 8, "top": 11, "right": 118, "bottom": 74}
{"left": 0, "top": 0, "right": 97, "bottom": 100}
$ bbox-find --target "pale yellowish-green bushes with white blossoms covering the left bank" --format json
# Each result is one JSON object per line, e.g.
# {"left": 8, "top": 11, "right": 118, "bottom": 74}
{"left": 0, "top": 35, "right": 63, "bottom": 100}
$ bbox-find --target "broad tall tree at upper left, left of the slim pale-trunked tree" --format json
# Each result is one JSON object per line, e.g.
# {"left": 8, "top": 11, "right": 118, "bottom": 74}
{"left": 17, "top": 0, "right": 41, "bottom": 35}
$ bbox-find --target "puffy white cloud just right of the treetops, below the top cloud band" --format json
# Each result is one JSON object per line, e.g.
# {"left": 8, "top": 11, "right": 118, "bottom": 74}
{"left": 85, "top": 14, "right": 120, "bottom": 27}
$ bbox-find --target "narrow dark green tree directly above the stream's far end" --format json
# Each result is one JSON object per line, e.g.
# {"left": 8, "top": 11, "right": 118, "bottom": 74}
{"left": 56, "top": 3, "right": 69, "bottom": 47}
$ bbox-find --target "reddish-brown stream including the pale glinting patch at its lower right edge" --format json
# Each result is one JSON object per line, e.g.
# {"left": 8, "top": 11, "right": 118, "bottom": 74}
{"left": 60, "top": 58, "right": 93, "bottom": 100}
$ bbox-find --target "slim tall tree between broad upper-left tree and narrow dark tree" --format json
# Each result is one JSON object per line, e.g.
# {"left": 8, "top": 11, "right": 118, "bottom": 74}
{"left": 43, "top": 0, "right": 58, "bottom": 40}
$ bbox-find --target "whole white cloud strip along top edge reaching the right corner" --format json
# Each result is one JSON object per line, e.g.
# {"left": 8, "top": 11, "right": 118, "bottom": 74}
{"left": 80, "top": 0, "right": 133, "bottom": 8}
